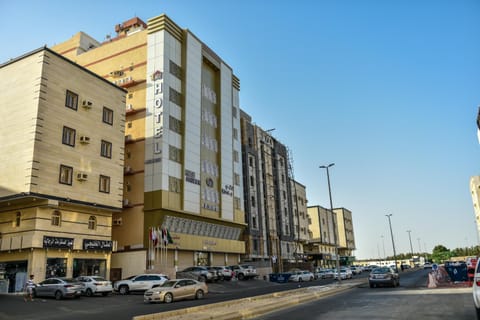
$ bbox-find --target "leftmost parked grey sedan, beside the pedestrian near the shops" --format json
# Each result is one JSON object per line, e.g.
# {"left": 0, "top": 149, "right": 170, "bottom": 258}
{"left": 33, "top": 278, "right": 85, "bottom": 300}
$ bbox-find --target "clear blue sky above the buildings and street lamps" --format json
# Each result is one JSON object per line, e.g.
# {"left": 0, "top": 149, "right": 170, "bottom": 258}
{"left": 0, "top": 0, "right": 480, "bottom": 258}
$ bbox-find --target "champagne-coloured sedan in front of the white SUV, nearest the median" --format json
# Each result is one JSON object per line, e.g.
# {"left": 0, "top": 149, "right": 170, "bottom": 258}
{"left": 143, "top": 279, "right": 208, "bottom": 303}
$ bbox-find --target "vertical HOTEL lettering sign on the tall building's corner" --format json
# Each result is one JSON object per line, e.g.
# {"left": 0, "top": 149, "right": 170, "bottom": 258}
{"left": 151, "top": 70, "right": 163, "bottom": 162}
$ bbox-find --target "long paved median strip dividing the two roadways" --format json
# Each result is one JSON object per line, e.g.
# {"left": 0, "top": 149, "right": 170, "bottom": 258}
{"left": 133, "top": 279, "right": 368, "bottom": 320}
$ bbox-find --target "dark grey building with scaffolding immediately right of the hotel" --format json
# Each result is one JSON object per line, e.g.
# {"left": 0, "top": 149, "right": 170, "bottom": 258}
{"left": 241, "top": 111, "right": 304, "bottom": 272}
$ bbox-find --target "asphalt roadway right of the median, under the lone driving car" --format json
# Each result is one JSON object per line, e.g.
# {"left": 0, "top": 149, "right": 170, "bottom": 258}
{"left": 256, "top": 270, "right": 476, "bottom": 320}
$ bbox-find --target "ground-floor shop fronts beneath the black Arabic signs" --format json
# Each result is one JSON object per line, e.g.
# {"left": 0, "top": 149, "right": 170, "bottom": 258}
{"left": 0, "top": 248, "right": 111, "bottom": 293}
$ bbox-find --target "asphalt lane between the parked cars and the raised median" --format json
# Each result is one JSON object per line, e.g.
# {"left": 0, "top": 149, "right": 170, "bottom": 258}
{"left": 0, "top": 275, "right": 346, "bottom": 320}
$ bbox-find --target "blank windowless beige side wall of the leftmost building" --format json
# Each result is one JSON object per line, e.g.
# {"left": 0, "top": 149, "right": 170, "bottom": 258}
{"left": 0, "top": 53, "right": 43, "bottom": 197}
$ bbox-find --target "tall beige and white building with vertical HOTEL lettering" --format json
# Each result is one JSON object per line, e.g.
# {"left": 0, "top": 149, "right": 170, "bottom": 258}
{"left": 52, "top": 15, "right": 246, "bottom": 278}
